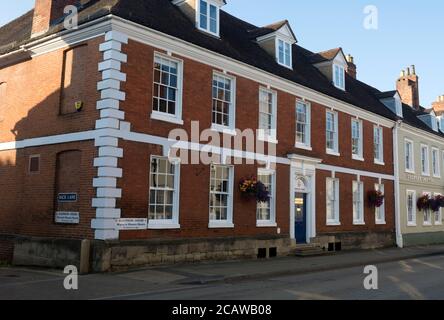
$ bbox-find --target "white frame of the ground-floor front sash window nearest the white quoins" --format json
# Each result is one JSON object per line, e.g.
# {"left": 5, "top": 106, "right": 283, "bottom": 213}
{"left": 148, "top": 155, "right": 180, "bottom": 230}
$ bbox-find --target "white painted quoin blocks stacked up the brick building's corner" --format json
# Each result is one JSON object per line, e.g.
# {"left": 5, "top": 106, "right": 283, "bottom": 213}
{"left": 91, "top": 31, "right": 128, "bottom": 240}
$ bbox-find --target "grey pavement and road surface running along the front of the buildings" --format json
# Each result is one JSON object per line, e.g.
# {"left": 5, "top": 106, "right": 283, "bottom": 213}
{"left": 0, "top": 245, "right": 444, "bottom": 300}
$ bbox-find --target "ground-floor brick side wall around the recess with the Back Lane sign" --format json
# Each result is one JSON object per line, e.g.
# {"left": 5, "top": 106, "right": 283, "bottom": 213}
{"left": 0, "top": 141, "right": 96, "bottom": 238}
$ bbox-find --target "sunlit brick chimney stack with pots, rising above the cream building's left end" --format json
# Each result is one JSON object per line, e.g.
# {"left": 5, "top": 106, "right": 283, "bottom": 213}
{"left": 396, "top": 65, "right": 420, "bottom": 110}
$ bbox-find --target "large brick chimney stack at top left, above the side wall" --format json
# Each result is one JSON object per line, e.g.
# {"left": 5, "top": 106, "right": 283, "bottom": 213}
{"left": 31, "top": 0, "right": 90, "bottom": 37}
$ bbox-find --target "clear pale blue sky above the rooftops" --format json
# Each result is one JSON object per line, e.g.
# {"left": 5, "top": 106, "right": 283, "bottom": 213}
{"left": 0, "top": 0, "right": 444, "bottom": 107}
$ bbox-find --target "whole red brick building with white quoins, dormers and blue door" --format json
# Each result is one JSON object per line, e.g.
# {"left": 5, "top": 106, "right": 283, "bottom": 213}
{"left": 0, "top": 0, "right": 397, "bottom": 270}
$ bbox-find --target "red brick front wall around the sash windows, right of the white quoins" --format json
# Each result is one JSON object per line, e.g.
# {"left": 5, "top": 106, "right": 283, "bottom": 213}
{"left": 115, "top": 40, "right": 394, "bottom": 239}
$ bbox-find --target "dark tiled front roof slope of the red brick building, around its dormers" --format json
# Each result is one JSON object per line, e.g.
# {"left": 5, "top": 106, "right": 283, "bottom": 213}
{"left": 0, "top": 0, "right": 414, "bottom": 125}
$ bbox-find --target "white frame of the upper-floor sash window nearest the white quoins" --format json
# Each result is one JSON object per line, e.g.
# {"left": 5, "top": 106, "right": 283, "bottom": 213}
{"left": 151, "top": 52, "right": 184, "bottom": 125}
